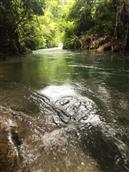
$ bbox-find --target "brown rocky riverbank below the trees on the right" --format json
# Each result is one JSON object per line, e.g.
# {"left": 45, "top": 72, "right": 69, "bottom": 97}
{"left": 64, "top": 33, "right": 128, "bottom": 53}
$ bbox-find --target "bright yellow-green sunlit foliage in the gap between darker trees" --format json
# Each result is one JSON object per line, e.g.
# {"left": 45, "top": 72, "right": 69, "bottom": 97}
{"left": 38, "top": 0, "right": 74, "bottom": 48}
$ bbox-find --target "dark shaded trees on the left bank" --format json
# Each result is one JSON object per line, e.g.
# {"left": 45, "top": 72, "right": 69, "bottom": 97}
{"left": 0, "top": 0, "right": 43, "bottom": 53}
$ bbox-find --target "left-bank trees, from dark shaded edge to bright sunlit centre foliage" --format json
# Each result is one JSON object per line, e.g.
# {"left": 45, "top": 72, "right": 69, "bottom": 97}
{"left": 0, "top": 0, "right": 72, "bottom": 54}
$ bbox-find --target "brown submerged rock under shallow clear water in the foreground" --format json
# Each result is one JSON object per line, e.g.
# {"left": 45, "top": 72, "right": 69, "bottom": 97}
{"left": 0, "top": 107, "right": 101, "bottom": 172}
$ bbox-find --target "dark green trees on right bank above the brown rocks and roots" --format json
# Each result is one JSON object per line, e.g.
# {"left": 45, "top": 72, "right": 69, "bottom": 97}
{"left": 64, "top": 0, "right": 129, "bottom": 49}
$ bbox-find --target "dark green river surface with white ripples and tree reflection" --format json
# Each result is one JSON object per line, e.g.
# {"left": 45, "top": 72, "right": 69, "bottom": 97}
{"left": 0, "top": 49, "right": 129, "bottom": 172}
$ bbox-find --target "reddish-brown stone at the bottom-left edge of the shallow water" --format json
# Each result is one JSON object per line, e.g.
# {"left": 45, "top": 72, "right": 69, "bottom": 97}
{"left": 0, "top": 115, "right": 22, "bottom": 172}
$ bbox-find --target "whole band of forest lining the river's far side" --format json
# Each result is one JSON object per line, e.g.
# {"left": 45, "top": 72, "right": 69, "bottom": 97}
{"left": 0, "top": 0, "right": 129, "bottom": 54}
